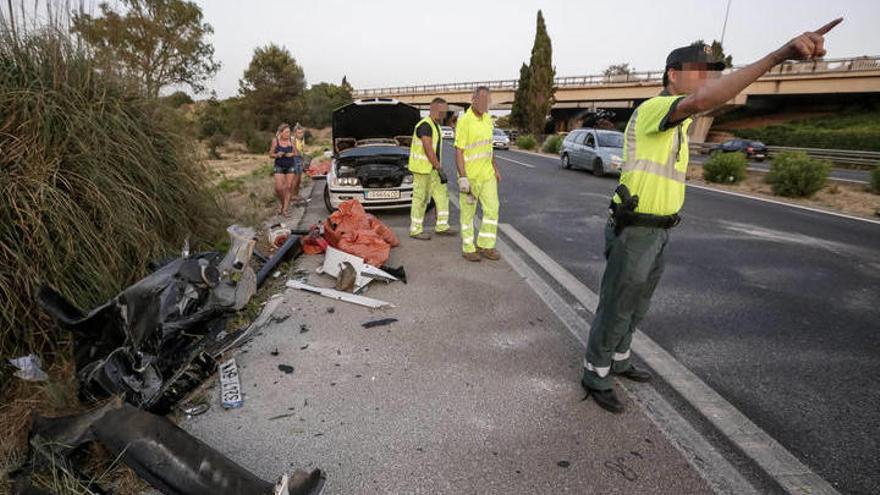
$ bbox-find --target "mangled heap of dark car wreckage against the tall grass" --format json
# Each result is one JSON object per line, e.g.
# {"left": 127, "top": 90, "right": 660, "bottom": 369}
{"left": 38, "top": 225, "right": 257, "bottom": 413}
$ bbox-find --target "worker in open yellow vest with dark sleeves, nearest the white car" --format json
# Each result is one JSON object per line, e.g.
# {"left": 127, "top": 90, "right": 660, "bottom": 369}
{"left": 409, "top": 98, "right": 456, "bottom": 241}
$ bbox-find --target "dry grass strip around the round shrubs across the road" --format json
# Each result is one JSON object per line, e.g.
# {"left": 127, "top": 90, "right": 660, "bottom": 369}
{"left": 687, "top": 163, "right": 880, "bottom": 219}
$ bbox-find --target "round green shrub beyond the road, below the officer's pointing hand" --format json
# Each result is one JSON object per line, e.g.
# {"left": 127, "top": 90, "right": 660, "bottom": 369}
{"left": 767, "top": 151, "right": 831, "bottom": 197}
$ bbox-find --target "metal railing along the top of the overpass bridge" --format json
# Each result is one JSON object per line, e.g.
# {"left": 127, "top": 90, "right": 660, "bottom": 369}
{"left": 353, "top": 55, "right": 880, "bottom": 98}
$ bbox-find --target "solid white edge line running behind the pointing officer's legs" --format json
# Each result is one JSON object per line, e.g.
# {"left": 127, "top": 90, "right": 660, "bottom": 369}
{"left": 498, "top": 224, "right": 838, "bottom": 495}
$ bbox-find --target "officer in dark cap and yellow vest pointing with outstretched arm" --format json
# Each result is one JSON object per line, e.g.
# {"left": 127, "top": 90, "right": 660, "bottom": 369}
{"left": 581, "top": 19, "right": 842, "bottom": 413}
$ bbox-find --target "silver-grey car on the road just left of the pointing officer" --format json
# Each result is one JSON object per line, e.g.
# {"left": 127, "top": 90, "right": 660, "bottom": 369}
{"left": 559, "top": 128, "right": 623, "bottom": 177}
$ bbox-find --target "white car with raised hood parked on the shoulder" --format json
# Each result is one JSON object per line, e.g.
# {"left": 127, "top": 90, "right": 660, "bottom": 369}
{"left": 324, "top": 98, "right": 420, "bottom": 212}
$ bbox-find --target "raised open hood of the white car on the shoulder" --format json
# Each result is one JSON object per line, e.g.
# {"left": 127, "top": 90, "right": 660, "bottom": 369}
{"left": 333, "top": 98, "right": 420, "bottom": 152}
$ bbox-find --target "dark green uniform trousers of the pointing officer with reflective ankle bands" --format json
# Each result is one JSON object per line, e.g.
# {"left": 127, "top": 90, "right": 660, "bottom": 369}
{"left": 582, "top": 222, "right": 669, "bottom": 390}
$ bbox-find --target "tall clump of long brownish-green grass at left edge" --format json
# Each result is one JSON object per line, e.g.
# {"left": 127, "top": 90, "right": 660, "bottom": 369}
{"left": 0, "top": 16, "right": 218, "bottom": 356}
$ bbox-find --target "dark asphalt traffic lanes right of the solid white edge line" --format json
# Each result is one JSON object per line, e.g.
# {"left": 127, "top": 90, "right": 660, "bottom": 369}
{"left": 444, "top": 143, "right": 880, "bottom": 494}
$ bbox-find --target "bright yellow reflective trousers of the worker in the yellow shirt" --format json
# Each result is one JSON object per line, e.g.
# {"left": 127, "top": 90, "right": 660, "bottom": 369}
{"left": 458, "top": 177, "right": 500, "bottom": 253}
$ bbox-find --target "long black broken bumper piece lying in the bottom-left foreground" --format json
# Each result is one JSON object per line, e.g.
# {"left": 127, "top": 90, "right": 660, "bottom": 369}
{"left": 18, "top": 400, "right": 325, "bottom": 495}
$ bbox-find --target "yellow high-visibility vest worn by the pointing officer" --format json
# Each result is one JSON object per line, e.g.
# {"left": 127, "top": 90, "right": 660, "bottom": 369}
{"left": 613, "top": 96, "right": 692, "bottom": 215}
